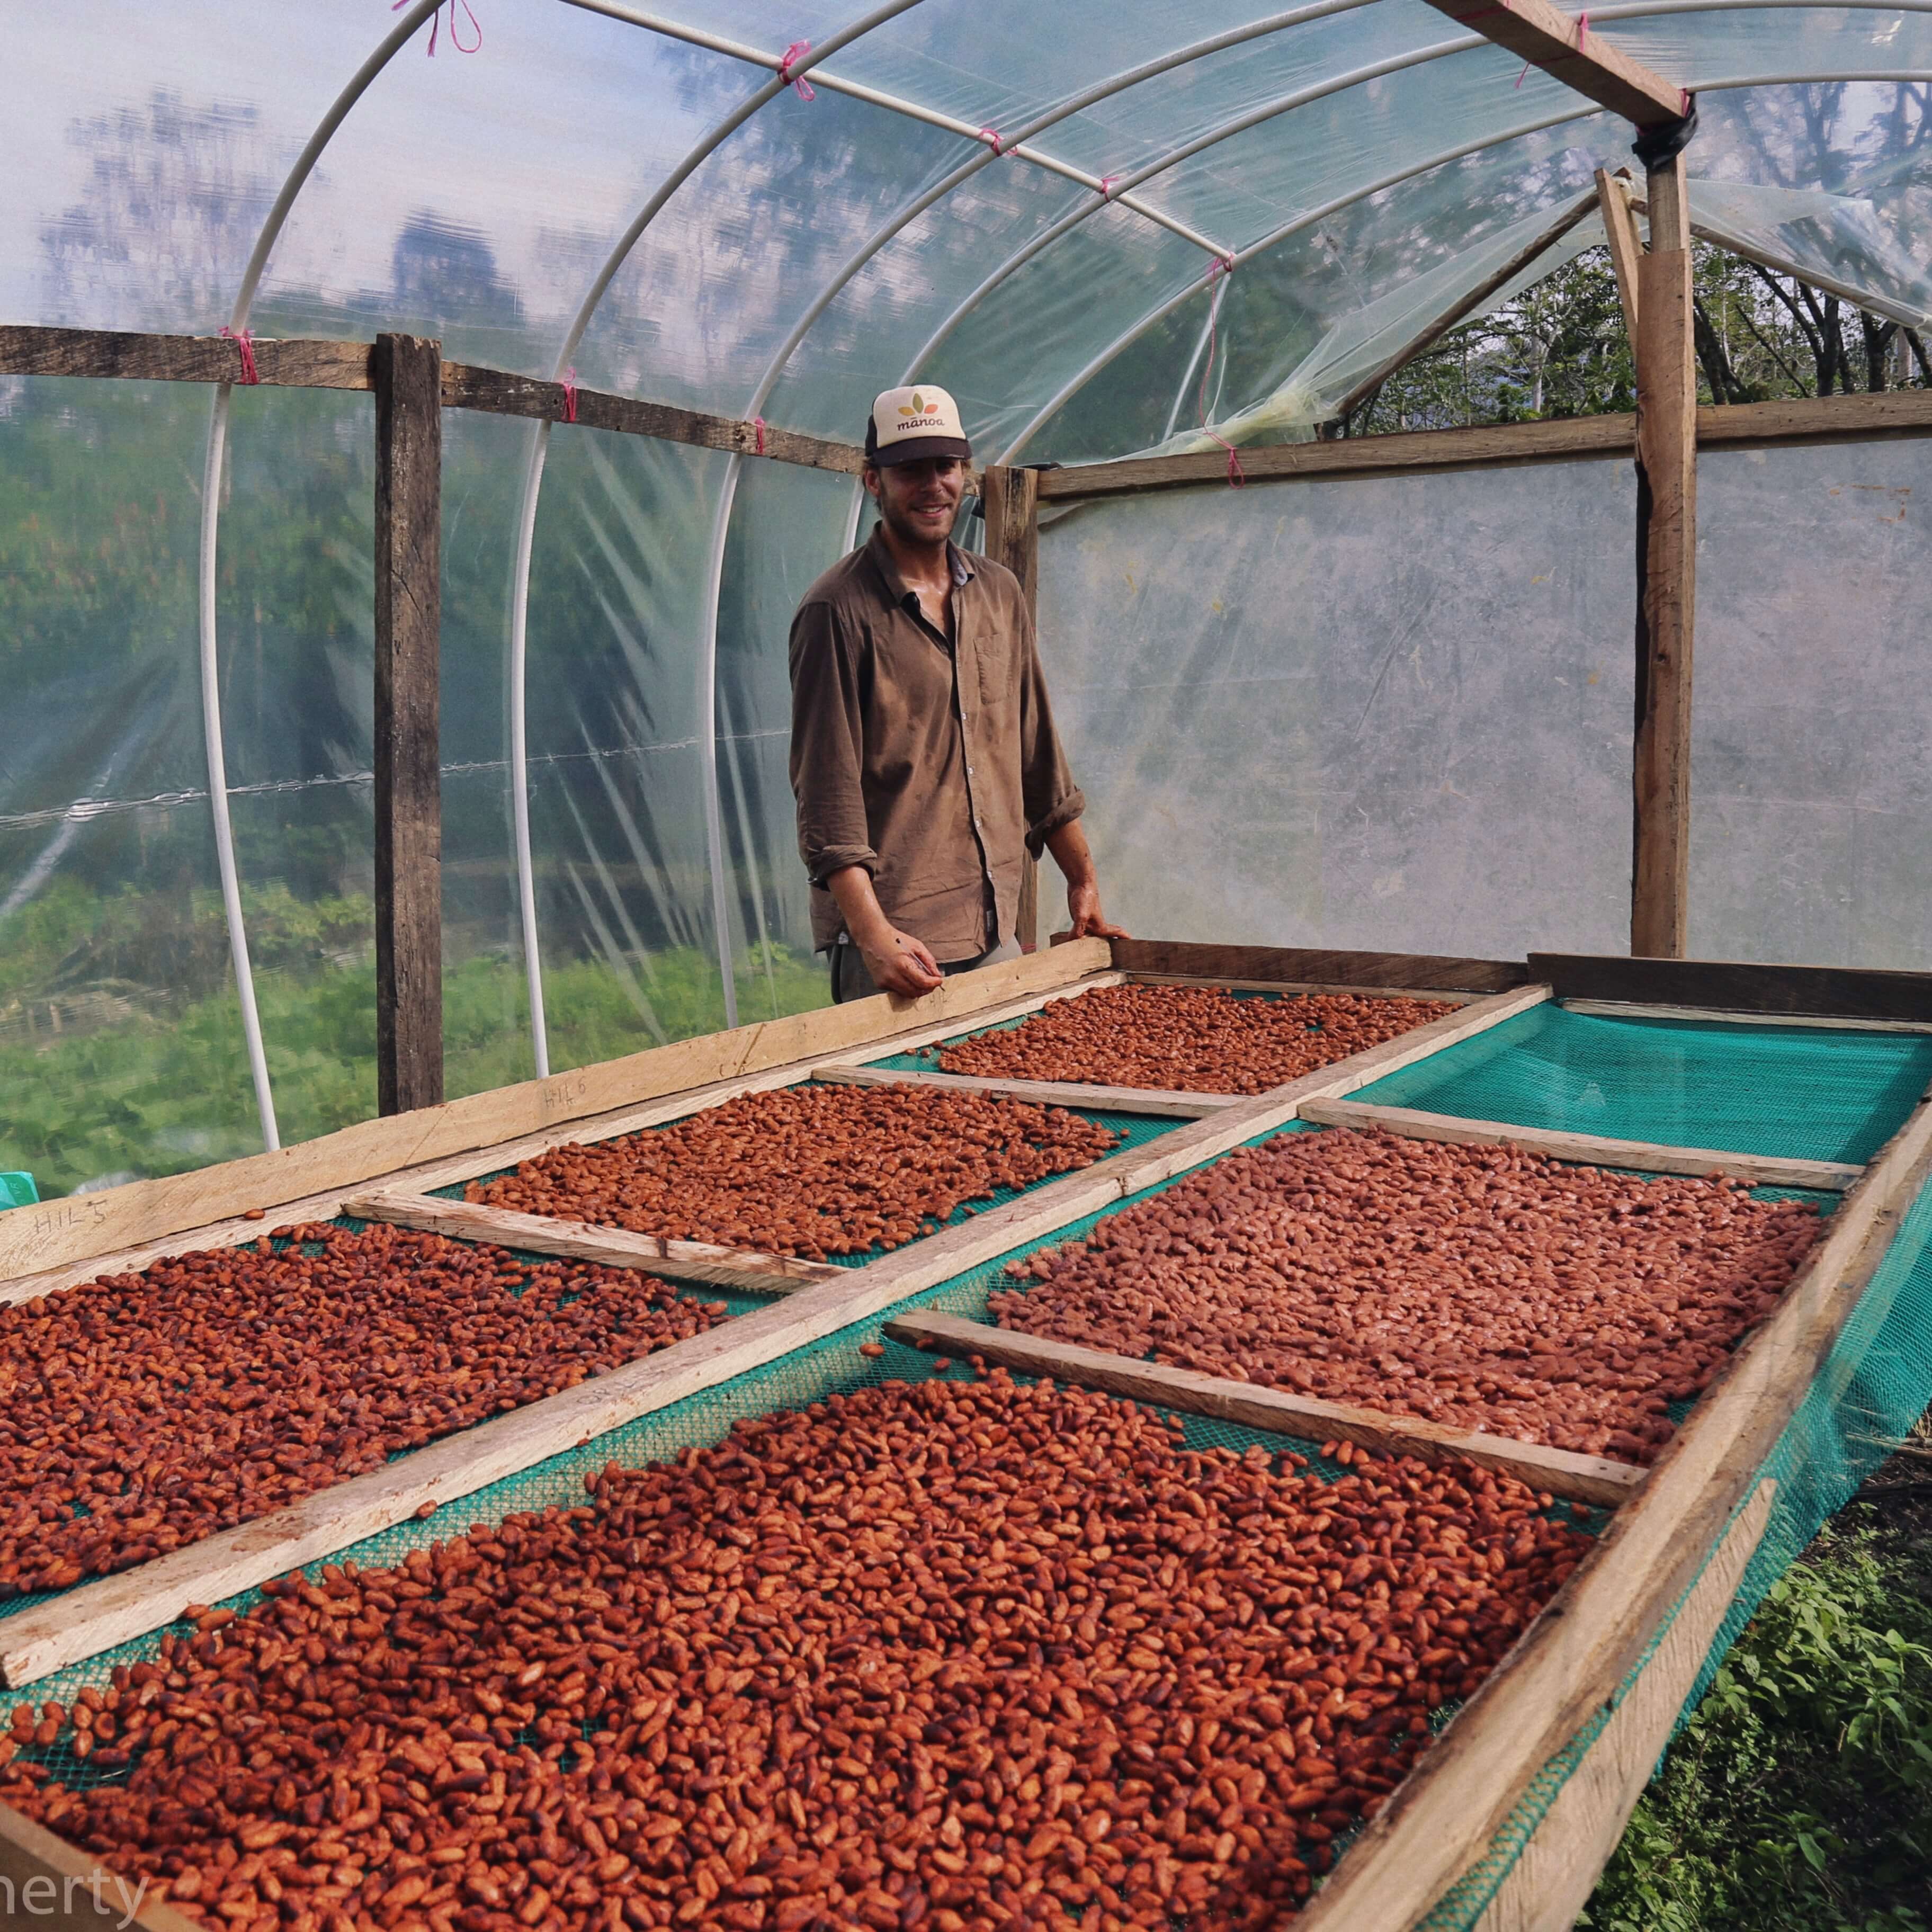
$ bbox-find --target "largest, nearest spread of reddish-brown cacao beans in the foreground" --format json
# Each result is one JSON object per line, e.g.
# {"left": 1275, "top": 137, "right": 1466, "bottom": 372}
{"left": 0, "top": 1374, "right": 1588, "bottom": 1932}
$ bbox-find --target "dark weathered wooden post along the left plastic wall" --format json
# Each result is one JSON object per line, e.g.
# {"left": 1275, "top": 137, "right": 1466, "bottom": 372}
{"left": 373, "top": 336, "right": 442, "bottom": 1113}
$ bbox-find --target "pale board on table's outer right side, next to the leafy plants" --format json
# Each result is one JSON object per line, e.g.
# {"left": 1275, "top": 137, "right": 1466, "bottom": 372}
{"left": 1474, "top": 1482, "right": 1777, "bottom": 1932}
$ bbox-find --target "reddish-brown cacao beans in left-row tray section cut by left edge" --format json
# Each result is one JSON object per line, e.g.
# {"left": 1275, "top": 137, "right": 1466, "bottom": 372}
{"left": 0, "top": 1223, "right": 724, "bottom": 1602}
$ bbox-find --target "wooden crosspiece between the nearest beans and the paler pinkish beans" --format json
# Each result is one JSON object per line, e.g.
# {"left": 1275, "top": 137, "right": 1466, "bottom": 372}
{"left": 885, "top": 1310, "right": 1646, "bottom": 1509}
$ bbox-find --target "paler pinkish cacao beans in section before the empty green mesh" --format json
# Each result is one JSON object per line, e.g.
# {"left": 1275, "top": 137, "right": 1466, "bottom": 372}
{"left": 989, "top": 1128, "right": 1820, "bottom": 1463}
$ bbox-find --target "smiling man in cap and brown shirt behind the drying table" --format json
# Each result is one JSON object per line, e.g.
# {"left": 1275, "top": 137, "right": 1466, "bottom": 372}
{"left": 792, "top": 382, "right": 1121, "bottom": 1001}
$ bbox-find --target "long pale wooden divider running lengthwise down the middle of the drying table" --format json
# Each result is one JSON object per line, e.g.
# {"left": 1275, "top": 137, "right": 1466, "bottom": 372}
{"left": 0, "top": 989, "right": 1548, "bottom": 1687}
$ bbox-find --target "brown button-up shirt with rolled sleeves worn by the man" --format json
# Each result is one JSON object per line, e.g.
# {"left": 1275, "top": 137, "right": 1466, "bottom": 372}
{"left": 792, "top": 530, "right": 1086, "bottom": 962}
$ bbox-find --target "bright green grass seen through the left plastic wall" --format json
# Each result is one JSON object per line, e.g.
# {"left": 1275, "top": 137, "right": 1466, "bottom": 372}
{"left": 0, "top": 885, "right": 829, "bottom": 1196}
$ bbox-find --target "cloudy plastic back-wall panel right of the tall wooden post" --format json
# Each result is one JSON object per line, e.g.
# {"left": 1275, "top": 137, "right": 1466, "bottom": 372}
{"left": 1690, "top": 442, "right": 1932, "bottom": 970}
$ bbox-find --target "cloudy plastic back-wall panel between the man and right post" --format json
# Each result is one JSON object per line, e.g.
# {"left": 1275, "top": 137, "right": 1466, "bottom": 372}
{"left": 1040, "top": 462, "right": 1636, "bottom": 958}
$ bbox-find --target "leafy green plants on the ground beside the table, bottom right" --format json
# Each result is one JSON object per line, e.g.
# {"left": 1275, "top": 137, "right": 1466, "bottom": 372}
{"left": 1580, "top": 1528, "right": 1932, "bottom": 1932}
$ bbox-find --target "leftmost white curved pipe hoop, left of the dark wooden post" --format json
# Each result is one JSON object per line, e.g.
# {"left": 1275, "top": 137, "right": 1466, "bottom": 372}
{"left": 197, "top": 0, "right": 439, "bottom": 1151}
